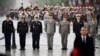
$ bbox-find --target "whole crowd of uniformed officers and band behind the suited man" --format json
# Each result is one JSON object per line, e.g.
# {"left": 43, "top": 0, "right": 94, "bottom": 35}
{"left": 2, "top": 4, "right": 100, "bottom": 56}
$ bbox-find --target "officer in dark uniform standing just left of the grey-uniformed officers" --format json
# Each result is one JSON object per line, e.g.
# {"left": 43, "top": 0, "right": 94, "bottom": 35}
{"left": 30, "top": 15, "right": 42, "bottom": 50}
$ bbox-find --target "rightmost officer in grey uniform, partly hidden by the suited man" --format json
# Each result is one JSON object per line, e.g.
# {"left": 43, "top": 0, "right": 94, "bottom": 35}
{"left": 88, "top": 16, "right": 98, "bottom": 47}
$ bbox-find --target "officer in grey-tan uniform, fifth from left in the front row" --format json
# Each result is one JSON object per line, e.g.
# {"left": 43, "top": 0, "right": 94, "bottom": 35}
{"left": 59, "top": 16, "right": 70, "bottom": 50}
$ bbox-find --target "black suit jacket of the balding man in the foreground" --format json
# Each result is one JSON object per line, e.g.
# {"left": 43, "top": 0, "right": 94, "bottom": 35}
{"left": 74, "top": 35, "right": 94, "bottom": 56}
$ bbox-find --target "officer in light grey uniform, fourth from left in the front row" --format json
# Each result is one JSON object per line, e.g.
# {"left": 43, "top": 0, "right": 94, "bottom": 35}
{"left": 45, "top": 12, "right": 56, "bottom": 50}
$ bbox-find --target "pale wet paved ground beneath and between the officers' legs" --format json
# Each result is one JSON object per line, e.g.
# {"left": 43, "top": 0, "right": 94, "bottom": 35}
{"left": 0, "top": 17, "right": 100, "bottom": 56}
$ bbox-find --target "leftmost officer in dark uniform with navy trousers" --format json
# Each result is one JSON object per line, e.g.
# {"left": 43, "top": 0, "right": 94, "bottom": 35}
{"left": 2, "top": 15, "right": 14, "bottom": 51}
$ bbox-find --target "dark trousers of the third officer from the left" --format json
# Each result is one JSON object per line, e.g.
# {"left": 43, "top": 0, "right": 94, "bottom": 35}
{"left": 32, "top": 34, "right": 40, "bottom": 49}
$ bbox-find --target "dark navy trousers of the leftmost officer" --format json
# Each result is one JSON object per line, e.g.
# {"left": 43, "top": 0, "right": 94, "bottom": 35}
{"left": 4, "top": 33, "right": 11, "bottom": 50}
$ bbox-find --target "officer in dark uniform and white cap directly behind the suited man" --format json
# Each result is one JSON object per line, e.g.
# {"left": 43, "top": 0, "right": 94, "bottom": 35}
{"left": 73, "top": 14, "right": 84, "bottom": 37}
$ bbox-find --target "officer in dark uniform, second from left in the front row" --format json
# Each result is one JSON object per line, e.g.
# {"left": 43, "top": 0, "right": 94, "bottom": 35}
{"left": 17, "top": 17, "right": 28, "bottom": 50}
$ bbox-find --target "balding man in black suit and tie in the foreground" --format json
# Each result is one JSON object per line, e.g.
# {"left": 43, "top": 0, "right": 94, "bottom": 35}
{"left": 74, "top": 27, "right": 94, "bottom": 56}
